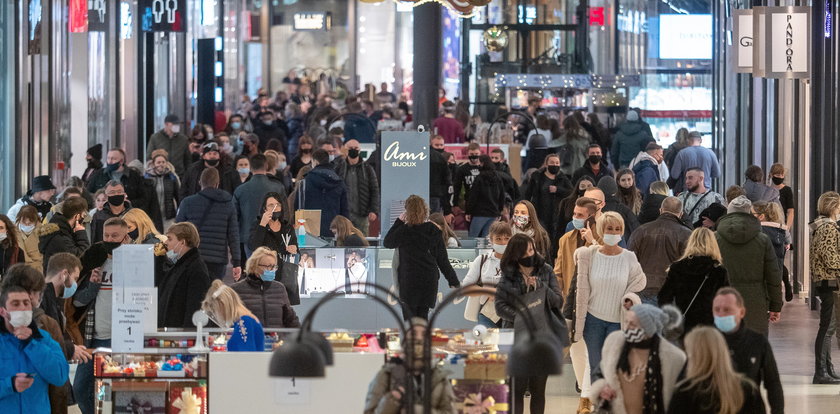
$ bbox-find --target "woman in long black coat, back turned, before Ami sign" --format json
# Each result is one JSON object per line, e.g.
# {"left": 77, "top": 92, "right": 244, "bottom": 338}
{"left": 383, "top": 195, "right": 461, "bottom": 320}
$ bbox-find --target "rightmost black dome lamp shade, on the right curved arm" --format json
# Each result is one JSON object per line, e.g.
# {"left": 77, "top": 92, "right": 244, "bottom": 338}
{"left": 507, "top": 336, "right": 562, "bottom": 377}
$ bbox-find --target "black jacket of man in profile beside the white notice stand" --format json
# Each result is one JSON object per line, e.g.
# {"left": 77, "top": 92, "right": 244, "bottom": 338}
{"left": 158, "top": 249, "right": 210, "bottom": 328}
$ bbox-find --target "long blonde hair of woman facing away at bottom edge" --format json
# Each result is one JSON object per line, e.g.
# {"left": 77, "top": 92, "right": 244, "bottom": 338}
{"left": 678, "top": 326, "right": 745, "bottom": 414}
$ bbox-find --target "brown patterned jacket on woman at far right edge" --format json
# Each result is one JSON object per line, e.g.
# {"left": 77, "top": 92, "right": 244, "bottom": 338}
{"left": 809, "top": 216, "right": 840, "bottom": 282}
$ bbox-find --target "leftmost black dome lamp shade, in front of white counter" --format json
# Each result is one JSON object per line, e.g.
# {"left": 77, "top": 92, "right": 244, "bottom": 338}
{"left": 268, "top": 340, "right": 326, "bottom": 378}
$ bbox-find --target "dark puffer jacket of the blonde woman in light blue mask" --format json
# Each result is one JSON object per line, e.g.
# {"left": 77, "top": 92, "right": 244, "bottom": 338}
{"left": 231, "top": 274, "right": 300, "bottom": 328}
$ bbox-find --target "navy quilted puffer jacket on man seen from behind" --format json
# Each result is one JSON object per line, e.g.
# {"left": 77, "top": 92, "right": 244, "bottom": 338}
{"left": 175, "top": 188, "right": 241, "bottom": 267}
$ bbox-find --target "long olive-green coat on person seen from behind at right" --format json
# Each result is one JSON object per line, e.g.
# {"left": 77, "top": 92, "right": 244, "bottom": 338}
{"left": 715, "top": 213, "right": 780, "bottom": 335}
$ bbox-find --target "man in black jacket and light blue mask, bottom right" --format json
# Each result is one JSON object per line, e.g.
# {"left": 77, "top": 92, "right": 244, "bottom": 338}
{"left": 712, "top": 287, "right": 785, "bottom": 414}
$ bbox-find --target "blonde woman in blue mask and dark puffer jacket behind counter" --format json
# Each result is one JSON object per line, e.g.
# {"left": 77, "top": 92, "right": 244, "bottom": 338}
{"left": 231, "top": 247, "right": 300, "bottom": 328}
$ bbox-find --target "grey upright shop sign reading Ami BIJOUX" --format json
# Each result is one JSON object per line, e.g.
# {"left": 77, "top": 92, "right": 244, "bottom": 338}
{"left": 380, "top": 131, "right": 430, "bottom": 235}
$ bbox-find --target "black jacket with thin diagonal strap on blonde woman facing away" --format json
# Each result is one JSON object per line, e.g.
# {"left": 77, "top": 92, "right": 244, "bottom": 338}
{"left": 658, "top": 256, "right": 729, "bottom": 333}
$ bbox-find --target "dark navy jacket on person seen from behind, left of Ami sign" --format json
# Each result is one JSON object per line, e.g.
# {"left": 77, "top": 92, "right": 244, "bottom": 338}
{"left": 295, "top": 165, "right": 350, "bottom": 237}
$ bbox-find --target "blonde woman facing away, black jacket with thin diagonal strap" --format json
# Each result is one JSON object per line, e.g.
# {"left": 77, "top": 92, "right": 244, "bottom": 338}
{"left": 659, "top": 227, "right": 729, "bottom": 332}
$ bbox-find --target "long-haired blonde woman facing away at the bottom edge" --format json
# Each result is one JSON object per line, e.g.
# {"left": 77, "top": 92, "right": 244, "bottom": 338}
{"left": 667, "top": 327, "right": 766, "bottom": 414}
